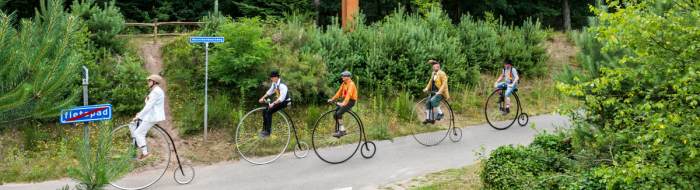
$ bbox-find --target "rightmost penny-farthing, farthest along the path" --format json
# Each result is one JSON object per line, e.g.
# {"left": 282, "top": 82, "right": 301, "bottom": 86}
{"left": 484, "top": 85, "right": 529, "bottom": 130}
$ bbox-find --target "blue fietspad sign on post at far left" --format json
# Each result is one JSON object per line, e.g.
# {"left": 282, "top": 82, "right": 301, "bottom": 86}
{"left": 61, "top": 104, "right": 112, "bottom": 124}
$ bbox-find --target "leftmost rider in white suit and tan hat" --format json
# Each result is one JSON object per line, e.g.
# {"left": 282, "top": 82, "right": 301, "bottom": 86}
{"left": 129, "top": 75, "right": 165, "bottom": 162}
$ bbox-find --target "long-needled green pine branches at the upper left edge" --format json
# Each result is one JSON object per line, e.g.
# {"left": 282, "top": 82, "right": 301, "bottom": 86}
{"left": 0, "top": 0, "right": 88, "bottom": 127}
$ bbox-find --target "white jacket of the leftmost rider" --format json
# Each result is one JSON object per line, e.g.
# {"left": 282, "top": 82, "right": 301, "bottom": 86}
{"left": 136, "top": 86, "right": 165, "bottom": 123}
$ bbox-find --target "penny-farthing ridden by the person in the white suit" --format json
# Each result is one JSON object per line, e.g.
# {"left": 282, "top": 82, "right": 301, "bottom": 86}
{"left": 110, "top": 120, "right": 194, "bottom": 189}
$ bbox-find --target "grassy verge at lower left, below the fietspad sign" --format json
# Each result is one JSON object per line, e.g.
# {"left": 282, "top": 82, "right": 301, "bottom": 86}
{"left": 0, "top": 118, "right": 134, "bottom": 184}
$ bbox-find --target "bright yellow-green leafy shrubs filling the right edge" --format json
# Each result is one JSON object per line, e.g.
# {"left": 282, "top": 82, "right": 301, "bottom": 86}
{"left": 484, "top": 0, "right": 700, "bottom": 189}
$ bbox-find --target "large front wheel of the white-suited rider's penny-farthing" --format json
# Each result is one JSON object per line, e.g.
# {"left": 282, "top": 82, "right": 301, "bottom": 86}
{"left": 110, "top": 124, "right": 170, "bottom": 189}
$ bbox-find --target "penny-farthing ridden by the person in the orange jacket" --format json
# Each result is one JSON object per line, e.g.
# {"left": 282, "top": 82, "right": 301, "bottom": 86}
{"left": 311, "top": 101, "right": 377, "bottom": 164}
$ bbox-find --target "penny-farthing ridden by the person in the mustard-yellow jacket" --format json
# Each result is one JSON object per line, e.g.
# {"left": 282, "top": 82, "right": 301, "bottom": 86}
{"left": 410, "top": 93, "right": 462, "bottom": 146}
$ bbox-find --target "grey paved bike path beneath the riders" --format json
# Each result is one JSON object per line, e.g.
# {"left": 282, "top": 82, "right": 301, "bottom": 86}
{"left": 0, "top": 115, "right": 569, "bottom": 190}
